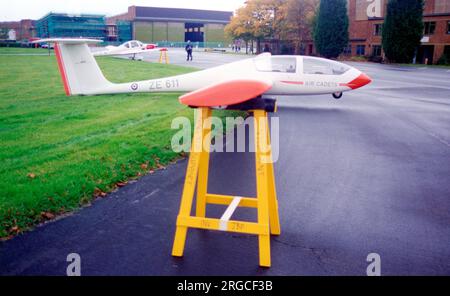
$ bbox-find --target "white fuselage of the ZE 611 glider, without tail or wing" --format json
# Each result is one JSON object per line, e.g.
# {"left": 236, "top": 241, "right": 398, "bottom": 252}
{"left": 101, "top": 55, "right": 361, "bottom": 95}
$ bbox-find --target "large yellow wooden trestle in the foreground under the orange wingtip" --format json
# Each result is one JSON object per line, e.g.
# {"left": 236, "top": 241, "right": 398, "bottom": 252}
{"left": 172, "top": 108, "right": 280, "bottom": 267}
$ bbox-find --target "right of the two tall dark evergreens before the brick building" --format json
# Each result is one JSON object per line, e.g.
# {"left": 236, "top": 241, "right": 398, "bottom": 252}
{"left": 382, "top": 0, "right": 424, "bottom": 63}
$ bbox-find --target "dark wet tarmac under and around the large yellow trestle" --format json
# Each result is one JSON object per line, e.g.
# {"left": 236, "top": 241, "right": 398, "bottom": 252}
{"left": 0, "top": 49, "right": 450, "bottom": 275}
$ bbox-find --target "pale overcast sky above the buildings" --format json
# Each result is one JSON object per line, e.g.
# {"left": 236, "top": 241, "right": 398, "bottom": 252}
{"left": 0, "top": 0, "right": 245, "bottom": 22}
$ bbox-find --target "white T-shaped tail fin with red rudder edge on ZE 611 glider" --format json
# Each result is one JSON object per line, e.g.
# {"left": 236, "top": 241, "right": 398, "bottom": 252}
{"left": 38, "top": 38, "right": 112, "bottom": 96}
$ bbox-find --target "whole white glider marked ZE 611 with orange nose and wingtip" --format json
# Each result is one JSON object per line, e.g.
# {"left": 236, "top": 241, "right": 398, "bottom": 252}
{"left": 36, "top": 39, "right": 371, "bottom": 104}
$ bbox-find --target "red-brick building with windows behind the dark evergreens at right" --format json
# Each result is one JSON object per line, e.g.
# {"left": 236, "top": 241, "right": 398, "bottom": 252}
{"left": 345, "top": 0, "right": 450, "bottom": 64}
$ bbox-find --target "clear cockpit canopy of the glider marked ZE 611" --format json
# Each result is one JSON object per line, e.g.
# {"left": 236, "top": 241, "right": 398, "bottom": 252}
{"left": 254, "top": 55, "right": 350, "bottom": 75}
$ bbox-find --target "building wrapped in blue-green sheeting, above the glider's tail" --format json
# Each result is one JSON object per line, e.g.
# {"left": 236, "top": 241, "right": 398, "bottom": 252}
{"left": 36, "top": 13, "right": 106, "bottom": 40}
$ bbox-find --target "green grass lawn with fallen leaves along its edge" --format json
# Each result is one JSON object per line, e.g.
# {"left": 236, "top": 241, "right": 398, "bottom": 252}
{"left": 0, "top": 48, "right": 243, "bottom": 237}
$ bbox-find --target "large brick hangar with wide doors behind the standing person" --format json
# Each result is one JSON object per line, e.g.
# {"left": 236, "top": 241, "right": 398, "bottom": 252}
{"left": 107, "top": 6, "right": 233, "bottom": 46}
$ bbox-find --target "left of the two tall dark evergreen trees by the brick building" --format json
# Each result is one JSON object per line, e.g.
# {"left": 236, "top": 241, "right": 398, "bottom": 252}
{"left": 313, "top": 0, "right": 348, "bottom": 58}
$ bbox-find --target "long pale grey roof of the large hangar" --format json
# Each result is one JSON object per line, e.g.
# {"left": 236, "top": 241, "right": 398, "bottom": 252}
{"left": 136, "top": 6, "right": 233, "bottom": 23}
